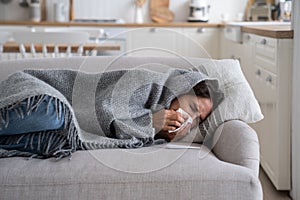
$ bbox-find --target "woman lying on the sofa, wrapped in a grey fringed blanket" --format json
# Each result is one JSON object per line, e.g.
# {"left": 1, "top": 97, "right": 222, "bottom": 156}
{"left": 0, "top": 69, "right": 222, "bottom": 157}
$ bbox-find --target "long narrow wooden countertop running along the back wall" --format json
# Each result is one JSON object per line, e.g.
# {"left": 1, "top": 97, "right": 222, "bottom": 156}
{"left": 0, "top": 21, "right": 223, "bottom": 28}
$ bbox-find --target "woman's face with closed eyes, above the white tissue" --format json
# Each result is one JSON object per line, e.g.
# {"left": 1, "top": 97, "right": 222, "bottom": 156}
{"left": 170, "top": 95, "right": 213, "bottom": 127}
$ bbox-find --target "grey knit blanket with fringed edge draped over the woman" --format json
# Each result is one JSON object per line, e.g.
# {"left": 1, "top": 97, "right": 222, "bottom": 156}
{"left": 0, "top": 69, "right": 218, "bottom": 157}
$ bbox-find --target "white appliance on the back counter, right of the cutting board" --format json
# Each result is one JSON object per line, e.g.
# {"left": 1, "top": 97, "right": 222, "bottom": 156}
{"left": 188, "top": 0, "right": 210, "bottom": 22}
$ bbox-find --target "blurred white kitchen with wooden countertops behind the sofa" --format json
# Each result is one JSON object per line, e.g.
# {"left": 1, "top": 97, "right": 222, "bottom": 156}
{"left": 0, "top": 0, "right": 300, "bottom": 200}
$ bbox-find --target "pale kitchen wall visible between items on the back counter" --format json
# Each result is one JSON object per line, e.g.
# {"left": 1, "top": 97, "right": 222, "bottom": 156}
{"left": 0, "top": 0, "right": 247, "bottom": 22}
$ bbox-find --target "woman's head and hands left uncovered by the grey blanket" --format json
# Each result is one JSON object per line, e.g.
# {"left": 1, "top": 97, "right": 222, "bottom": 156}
{"left": 153, "top": 81, "right": 213, "bottom": 142}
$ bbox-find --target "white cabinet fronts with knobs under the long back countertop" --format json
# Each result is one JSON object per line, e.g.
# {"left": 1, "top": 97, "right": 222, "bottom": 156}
{"left": 127, "top": 27, "right": 219, "bottom": 58}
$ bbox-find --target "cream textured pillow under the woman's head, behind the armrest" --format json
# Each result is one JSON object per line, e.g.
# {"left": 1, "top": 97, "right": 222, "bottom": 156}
{"left": 181, "top": 59, "right": 263, "bottom": 143}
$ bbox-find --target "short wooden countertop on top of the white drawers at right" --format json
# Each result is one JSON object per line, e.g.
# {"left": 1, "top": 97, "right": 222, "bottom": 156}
{"left": 241, "top": 25, "right": 294, "bottom": 39}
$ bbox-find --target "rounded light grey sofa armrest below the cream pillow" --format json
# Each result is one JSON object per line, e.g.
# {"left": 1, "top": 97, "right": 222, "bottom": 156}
{"left": 213, "top": 120, "right": 260, "bottom": 175}
